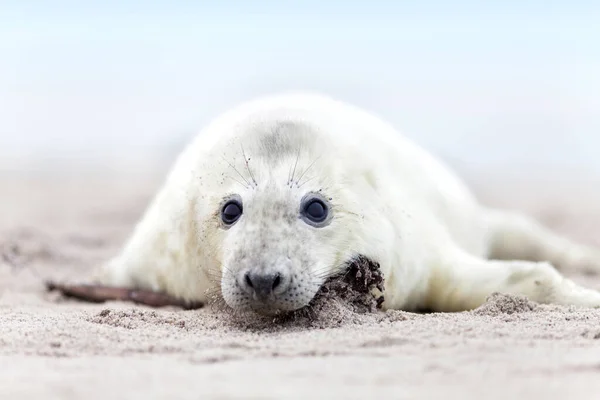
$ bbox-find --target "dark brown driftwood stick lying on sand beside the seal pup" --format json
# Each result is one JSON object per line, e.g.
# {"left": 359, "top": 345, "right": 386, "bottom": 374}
{"left": 46, "top": 281, "right": 203, "bottom": 310}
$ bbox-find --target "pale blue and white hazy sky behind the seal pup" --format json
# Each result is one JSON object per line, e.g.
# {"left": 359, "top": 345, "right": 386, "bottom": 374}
{"left": 0, "top": 0, "right": 600, "bottom": 174}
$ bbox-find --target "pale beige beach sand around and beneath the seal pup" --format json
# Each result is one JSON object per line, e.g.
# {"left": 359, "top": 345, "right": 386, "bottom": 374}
{"left": 0, "top": 167, "right": 600, "bottom": 400}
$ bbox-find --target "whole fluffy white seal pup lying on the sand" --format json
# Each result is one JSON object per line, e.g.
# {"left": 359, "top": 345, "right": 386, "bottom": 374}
{"left": 98, "top": 94, "right": 600, "bottom": 313}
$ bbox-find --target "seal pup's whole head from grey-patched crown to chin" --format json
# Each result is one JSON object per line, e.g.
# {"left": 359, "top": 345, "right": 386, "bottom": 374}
{"left": 214, "top": 120, "right": 356, "bottom": 314}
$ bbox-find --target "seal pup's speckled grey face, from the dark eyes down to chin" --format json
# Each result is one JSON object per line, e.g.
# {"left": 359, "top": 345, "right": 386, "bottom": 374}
{"left": 220, "top": 183, "right": 336, "bottom": 313}
